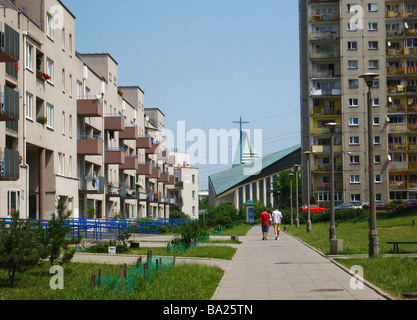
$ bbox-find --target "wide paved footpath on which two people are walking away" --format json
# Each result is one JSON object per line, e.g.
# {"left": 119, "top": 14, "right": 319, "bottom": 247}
{"left": 213, "top": 226, "right": 386, "bottom": 300}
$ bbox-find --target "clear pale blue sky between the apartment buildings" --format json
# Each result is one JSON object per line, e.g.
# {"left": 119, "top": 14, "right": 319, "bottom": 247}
{"left": 63, "top": 0, "right": 301, "bottom": 190}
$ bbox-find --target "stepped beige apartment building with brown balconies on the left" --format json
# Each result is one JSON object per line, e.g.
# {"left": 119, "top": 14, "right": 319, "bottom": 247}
{"left": 0, "top": 0, "right": 184, "bottom": 219}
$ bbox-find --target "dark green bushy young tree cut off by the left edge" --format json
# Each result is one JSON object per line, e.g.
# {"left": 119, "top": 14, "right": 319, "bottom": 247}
{"left": 0, "top": 211, "right": 43, "bottom": 287}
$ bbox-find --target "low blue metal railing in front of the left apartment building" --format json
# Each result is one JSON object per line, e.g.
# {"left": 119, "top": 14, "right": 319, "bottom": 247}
{"left": 0, "top": 218, "right": 190, "bottom": 240}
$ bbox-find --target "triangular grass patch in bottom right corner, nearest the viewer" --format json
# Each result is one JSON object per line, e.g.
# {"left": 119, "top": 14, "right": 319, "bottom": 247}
{"left": 336, "top": 257, "right": 417, "bottom": 299}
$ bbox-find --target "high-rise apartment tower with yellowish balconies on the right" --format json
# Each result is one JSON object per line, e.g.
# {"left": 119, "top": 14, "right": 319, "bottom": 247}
{"left": 299, "top": 0, "right": 417, "bottom": 206}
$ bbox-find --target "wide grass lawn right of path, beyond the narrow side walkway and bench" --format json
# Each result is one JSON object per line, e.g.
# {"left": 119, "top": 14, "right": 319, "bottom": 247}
{"left": 286, "top": 211, "right": 417, "bottom": 255}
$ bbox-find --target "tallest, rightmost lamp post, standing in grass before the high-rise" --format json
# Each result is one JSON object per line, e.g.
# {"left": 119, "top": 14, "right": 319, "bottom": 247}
{"left": 359, "top": 73, "right": 379, "bottom": 257}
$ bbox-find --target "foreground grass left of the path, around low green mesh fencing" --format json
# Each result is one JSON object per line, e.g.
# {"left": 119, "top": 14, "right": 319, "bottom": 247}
{"left": 0, "top": 263, "right": 224, "bottom": 300}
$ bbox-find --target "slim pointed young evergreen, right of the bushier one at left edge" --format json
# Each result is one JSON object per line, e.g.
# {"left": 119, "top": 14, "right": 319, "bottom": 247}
{"left": 42, "top": 202, "right": 81, "bottom": 266}
